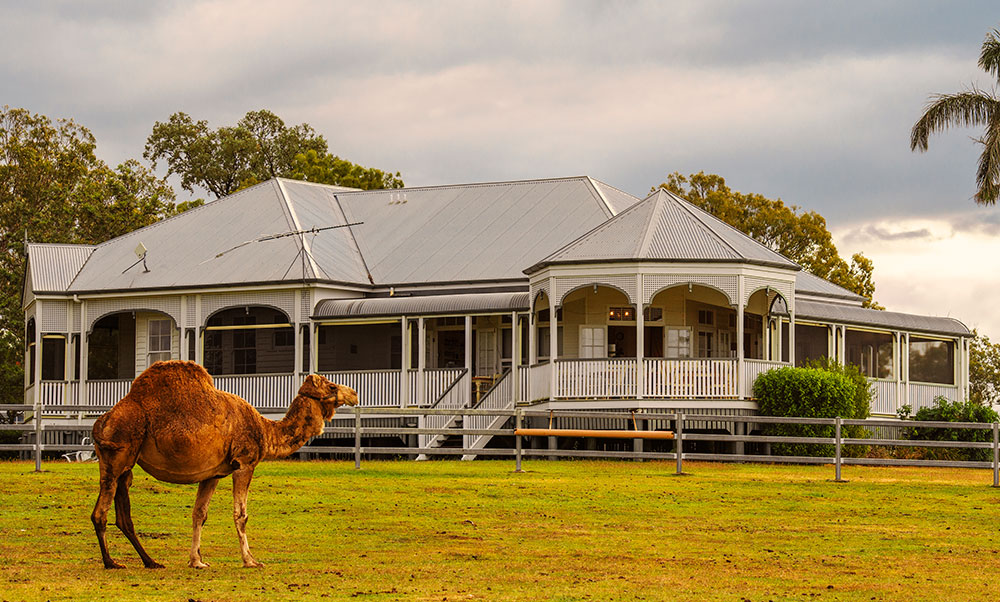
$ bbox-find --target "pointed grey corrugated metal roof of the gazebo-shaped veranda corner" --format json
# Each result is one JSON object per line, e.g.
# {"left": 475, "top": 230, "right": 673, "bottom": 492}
{"left": 526, "top": 189, "right": 801, "bottom": 273}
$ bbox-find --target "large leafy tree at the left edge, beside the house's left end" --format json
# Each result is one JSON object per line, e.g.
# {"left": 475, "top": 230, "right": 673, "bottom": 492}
{"left": 0, "top": 106, "right": 178, "bottom": 403}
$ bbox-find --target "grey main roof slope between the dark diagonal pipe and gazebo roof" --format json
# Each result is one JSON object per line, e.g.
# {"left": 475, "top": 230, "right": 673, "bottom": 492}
{"left": 337, "top": 177, "right": 611, "bottom": 285}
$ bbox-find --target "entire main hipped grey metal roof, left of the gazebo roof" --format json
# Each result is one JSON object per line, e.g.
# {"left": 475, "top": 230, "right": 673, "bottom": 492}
{"left": 28, "top": 177, "right": 638, "bottom": 293}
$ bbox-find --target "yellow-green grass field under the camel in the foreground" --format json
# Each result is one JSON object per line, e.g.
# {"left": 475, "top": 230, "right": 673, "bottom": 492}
{"left": 0, "top": 461, "right": 1000, "bottom": 601}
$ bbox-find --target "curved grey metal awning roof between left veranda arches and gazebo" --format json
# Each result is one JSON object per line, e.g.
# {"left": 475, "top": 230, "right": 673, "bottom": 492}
{"left": 313, "top": 292, "right": 528, "bottom": 319}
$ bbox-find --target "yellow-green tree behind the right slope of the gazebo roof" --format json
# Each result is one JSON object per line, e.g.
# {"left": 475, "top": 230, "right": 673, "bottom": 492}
{"left": 653, "top": 171, "right": 882, "bottom": 309}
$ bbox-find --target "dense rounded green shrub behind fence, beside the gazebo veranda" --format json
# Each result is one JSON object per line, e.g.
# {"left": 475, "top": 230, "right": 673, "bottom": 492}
{"left": 753, "top": 363, "right": 871, "bottom": 457}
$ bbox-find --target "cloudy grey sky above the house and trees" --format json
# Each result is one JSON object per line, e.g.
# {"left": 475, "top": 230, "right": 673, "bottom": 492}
{"left": 0, "top": 0, "right": 1000, "bottom": 339}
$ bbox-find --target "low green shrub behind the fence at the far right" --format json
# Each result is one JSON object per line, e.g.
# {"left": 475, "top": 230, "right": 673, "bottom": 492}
{"left": 900, "top": 396, "right": 1000, "bottom": 462}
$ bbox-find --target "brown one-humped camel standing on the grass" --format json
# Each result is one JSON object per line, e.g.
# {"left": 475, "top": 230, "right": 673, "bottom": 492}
{"left": 91, "top": 361, "right": 358, "bottom": 569}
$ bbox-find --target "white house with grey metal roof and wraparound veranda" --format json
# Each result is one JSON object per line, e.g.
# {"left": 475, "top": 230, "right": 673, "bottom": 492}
{"left": 24, "top": 177, "right": 970, "bottom": 442}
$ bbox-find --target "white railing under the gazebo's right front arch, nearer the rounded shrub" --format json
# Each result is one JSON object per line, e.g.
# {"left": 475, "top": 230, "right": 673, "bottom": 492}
{"left": 644, "top": 359, "right": 737, "bottom": 399}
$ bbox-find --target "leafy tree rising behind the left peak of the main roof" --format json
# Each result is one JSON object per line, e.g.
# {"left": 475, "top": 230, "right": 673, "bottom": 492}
{"left": 143, "top": 110, "right": 403, "bottom": 198}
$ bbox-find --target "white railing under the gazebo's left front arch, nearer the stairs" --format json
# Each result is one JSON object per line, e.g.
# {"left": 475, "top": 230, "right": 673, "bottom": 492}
{"left": 553, "top": 359, "right": 636, "bottom": 399}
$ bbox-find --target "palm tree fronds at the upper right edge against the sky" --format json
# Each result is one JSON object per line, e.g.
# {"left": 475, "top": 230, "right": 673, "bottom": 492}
{"left": 910, "top": 29, "right": 1000, "bottom": 205}
